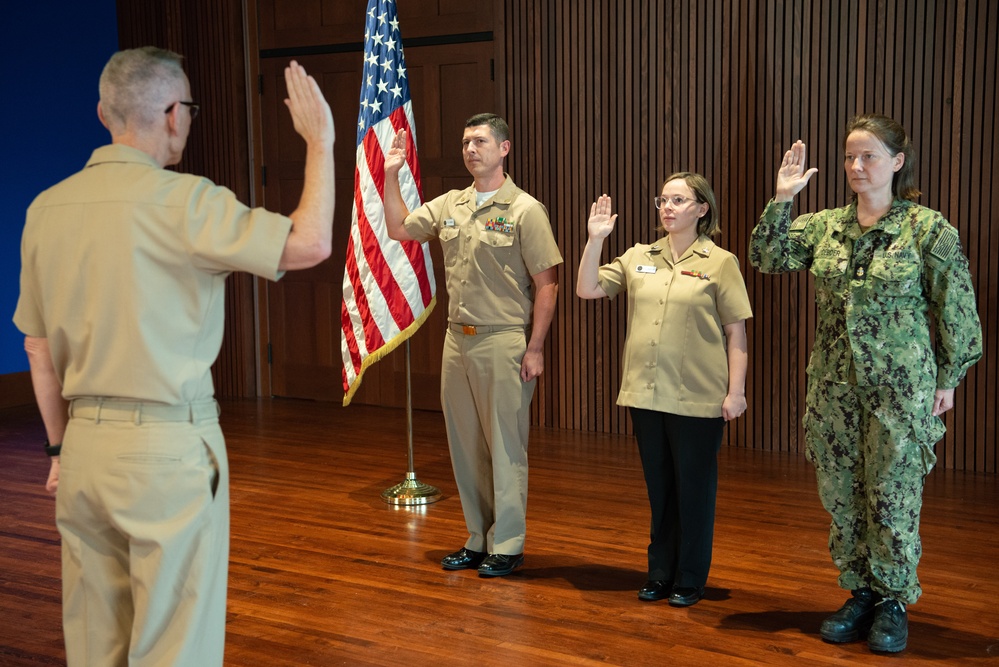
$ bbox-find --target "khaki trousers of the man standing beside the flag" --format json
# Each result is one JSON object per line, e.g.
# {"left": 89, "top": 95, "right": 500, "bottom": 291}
{"left": 441, "top": 328, "right": 537, "bottom": 554}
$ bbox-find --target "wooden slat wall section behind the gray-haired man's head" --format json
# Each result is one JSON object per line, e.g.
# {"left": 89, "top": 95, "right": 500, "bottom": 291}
{"left": 116, "top": 0, "right": 257, "bottom": 398}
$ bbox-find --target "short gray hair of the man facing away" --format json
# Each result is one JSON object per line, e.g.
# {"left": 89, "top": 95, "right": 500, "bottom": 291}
{"left": 100, "top": 46, "right": 185, "bottom": 134}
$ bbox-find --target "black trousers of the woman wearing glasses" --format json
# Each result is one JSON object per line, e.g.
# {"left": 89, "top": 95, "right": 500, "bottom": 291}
{"left": 630, "top": 408, "right": 725, "bottom": 588}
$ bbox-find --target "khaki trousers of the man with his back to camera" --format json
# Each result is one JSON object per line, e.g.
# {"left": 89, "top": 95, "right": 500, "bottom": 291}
{"left": 56, "top": 401, "right": 229, "bottom": 667}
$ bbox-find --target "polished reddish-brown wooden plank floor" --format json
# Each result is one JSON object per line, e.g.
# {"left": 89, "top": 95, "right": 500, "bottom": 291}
{"left": 0, "top": 400, "right": 999, "bottom": 667}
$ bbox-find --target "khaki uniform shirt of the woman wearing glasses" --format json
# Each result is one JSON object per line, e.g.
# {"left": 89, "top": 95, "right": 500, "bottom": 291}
{"left": 598, "top": 236, "right": 753, "bottom": 417}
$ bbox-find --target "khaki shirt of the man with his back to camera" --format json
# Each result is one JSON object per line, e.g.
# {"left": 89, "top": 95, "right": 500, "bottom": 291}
{"left": 14, "top": 145, "right": 291, "bottom": 404}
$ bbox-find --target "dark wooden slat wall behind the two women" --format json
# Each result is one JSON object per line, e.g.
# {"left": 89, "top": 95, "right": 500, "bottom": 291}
{"left": 501, "top": 0, "right": 999, "bottom": 473}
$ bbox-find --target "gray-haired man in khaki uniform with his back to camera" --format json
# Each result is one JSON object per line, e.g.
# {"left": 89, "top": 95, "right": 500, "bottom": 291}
{"left": 14, "top": 47, "right": 334, "bottom": 667}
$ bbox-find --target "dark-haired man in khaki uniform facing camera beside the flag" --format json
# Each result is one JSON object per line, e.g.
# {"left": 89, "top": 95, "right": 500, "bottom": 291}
{"left": 385, "top": 114, "right": 562, "bottom": 577}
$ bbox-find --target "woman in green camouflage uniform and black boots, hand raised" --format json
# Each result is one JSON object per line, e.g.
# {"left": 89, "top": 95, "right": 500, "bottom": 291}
{"left": 750, "top": 114, "right": 982, "bottom": 653}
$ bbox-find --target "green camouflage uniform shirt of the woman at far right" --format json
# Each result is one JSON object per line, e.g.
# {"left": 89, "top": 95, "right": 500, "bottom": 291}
{"left": 750, "top": 199, "right": 982, "bottom": 391}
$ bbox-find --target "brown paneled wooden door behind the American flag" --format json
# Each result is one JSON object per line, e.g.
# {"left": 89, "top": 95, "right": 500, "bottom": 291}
{"left": 260, "top": 32, "right": 496, "bottom": 410}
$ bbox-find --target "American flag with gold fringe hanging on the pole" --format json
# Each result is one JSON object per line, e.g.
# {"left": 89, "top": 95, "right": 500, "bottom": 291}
{"left": 340, "top": 0, "right": 437, "bottom": 405}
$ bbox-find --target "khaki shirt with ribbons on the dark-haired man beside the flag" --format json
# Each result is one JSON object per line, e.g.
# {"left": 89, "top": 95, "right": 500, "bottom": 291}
{"left": 405, "top": 175, "right": 562, "bottom": 325}
